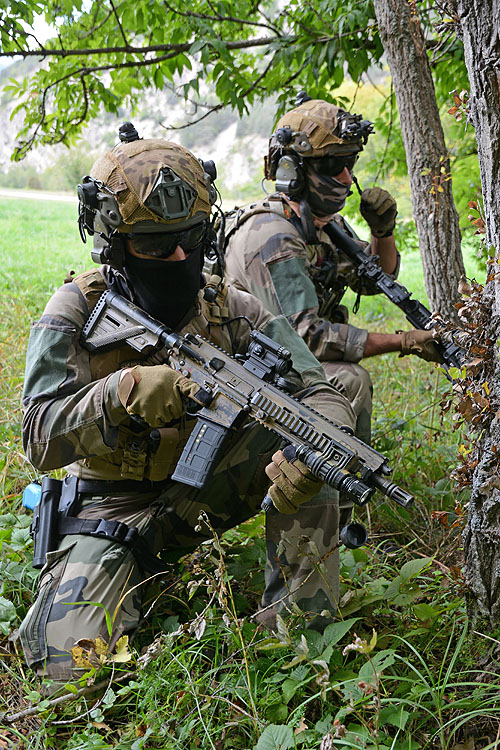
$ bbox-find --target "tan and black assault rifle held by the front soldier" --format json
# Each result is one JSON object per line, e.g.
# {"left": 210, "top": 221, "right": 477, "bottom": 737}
{"left": 82, "top": 290, "right": 413, "bottom": 508}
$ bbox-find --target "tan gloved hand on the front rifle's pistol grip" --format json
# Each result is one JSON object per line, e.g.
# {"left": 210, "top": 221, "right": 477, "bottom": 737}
{"left": 118, "top": 365, "right": 201, "bottom": 427}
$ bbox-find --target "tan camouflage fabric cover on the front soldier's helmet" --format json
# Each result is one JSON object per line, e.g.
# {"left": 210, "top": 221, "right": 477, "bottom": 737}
{"left": 91, "top": 138, "right": 211, "bottom": 232}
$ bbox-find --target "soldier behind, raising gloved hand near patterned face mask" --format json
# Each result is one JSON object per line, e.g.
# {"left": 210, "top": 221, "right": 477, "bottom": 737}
{"left": 226, "top": 95, "right": 441, "bottom": 442}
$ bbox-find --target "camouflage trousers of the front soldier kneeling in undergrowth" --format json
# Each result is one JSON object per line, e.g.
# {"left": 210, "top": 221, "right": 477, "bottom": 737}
{"left": 20, "top": 425, "right": 350, "bottom": 681}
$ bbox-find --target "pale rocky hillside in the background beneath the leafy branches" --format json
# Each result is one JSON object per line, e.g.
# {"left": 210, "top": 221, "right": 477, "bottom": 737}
{"left": 0, "top": 61, "right": 274, "bottom": 201}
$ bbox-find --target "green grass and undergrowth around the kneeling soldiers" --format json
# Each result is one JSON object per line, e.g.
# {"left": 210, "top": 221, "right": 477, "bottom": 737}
{"left": 0, "top": 199, "right": 499, "bottom": 750}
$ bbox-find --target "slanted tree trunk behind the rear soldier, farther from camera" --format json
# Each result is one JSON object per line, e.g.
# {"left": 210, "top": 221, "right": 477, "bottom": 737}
{"left": 374, "top": 0, "right": 465, "bottom": 320}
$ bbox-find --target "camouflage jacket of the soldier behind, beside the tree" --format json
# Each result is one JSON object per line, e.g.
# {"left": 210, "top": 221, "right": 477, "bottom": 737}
{"left": 226, "top": 194, "right": 399, "bottom": 362}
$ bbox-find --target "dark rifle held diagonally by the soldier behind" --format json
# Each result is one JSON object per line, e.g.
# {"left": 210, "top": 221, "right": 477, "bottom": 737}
{"left": 324, "top": 221, "right": 465, "bottom": 368}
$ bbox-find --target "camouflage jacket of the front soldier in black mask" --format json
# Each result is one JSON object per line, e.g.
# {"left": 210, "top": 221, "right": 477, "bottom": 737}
{"left": 23, "top": 266, "right": 352, "bottom": 481}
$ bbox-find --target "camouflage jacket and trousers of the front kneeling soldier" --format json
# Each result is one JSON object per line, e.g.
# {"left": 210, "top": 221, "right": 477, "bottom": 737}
{"left": 20, "top": 268, "right": 355, "bottom": 680}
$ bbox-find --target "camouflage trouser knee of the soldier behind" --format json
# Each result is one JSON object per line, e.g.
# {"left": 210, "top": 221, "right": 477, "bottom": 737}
{"left": 321, "top": 361, "right": 373, "bottom": 445}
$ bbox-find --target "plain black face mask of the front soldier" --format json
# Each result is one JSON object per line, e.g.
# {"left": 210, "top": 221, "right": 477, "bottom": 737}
{"left": 124, "top": 246, "right": 203, "bottom": 330}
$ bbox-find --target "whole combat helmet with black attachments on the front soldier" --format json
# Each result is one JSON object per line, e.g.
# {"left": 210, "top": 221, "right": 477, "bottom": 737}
{"left": 78, "top": 123, "right": 218, "bottom": 268}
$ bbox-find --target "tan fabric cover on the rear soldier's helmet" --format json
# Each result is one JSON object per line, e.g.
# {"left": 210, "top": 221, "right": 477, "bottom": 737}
{"left": 275, "top": 99, "right": 362, "bottom": 158}
